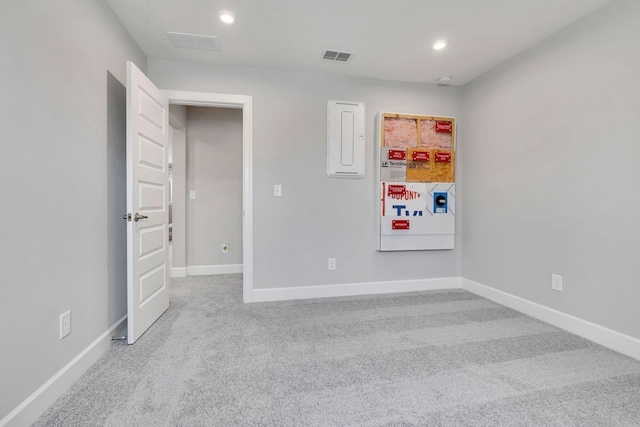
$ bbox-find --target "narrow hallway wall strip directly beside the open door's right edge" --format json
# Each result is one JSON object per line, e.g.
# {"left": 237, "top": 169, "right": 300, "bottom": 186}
{"left": 169, "top": 105, "right": 187, "bottom": 276}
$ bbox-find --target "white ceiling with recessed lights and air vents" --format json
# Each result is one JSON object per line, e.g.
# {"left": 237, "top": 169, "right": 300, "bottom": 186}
{"left": 106, "top": 0, "right": 611, "bottom": 86}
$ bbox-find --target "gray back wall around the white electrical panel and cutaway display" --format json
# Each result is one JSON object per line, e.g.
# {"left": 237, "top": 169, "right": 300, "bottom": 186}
{"left": 149, "top": 59, "right": 460, "bottom": 289}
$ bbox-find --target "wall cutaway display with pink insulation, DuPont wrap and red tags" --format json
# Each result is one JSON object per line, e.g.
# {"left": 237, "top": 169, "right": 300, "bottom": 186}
{"left": 378, "top": 113, "right": 456, "bottom": 251}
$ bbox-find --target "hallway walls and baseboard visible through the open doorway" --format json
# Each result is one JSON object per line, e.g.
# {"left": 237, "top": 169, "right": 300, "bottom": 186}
{"left": 169, "top": 104, "right": 242, "bottom": 277}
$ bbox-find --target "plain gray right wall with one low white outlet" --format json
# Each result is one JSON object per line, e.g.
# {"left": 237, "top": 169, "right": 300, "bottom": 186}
{"left": 458, "top": 0, "right": 640, "bottom": 338}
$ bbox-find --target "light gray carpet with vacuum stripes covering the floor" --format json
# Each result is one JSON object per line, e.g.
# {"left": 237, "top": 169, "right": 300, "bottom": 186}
{"left": 35, "top": 275, "right": 640, "bottom": 427}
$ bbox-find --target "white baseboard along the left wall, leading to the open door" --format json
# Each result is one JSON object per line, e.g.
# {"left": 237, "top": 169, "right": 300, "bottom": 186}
{"left": 0, "top": 315, "right": 127, "bottom": 427}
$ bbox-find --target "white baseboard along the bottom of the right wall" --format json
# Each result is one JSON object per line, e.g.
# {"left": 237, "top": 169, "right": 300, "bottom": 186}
{"left": 461, "top": 278, "right": 640, "bottom": 360}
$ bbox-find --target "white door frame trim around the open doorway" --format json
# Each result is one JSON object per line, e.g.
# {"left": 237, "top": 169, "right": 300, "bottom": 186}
{"left": 162, "top": 90, "right": 253, "bottom": 302}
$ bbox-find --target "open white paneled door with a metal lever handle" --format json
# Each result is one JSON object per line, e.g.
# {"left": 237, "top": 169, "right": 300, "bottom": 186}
{"left": 127, "top": 62, "right": 169, "bottom": 344}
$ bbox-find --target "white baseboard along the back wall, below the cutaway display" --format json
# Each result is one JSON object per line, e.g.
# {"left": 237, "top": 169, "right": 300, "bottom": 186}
{"left": 244, "top": 277, "right": 460, "bottom": 302}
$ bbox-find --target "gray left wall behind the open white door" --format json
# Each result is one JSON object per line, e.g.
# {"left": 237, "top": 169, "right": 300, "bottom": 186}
{"left": 0, "top": 0, "right": 146, "bottom": 425}
